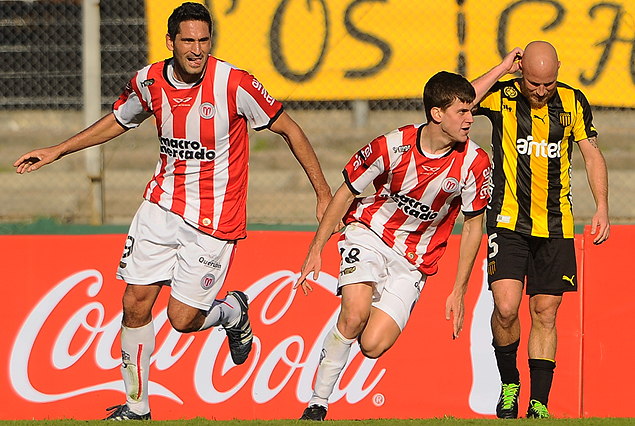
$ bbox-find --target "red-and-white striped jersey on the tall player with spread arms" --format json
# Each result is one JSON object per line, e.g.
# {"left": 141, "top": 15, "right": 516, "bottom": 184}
{"left": 113, "top": 56, "right": 282, "bottom": 240}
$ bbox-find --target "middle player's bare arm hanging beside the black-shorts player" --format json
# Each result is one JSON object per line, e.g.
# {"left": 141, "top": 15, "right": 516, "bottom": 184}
{"left": 445, "top": 213, "right": 484, "bottom": 339}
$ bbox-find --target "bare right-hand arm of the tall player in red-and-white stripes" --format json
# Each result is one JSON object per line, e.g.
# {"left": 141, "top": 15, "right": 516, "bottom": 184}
{"left": 271, "top": 112, "right": 331, "bottom": 222}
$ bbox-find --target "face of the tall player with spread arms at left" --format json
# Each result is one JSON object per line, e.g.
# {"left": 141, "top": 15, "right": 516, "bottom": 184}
{"left": 166, "top": 21, "right": 212, "bottom": 83}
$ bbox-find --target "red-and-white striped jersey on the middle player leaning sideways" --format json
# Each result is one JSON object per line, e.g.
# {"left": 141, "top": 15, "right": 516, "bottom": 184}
{"left": 343, "top": 124, "right": 490, "bottom": 275}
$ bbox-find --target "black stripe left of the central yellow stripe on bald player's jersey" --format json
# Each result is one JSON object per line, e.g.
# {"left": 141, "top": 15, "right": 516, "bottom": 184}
{"left": 515, "top": 96, "right": 533, "bottom": 235}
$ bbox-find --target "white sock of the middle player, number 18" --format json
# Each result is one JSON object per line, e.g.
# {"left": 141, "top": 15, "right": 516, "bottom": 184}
{"left": 309, "top": 325, "right": 355, "bottom": 407}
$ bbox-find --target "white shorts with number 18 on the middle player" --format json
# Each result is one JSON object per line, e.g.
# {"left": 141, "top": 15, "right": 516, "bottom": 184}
{"left": 337, "top": 223, "right": 427, "bottom": 330}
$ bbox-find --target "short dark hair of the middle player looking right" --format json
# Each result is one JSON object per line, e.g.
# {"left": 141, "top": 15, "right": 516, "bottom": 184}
{"left": 423, "top": 71, "right": 476, "bottom": 122}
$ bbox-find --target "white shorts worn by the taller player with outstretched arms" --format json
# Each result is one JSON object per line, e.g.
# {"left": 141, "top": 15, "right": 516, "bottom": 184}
{"left": 117, "top": 200, "right": 236, "bottom": 310}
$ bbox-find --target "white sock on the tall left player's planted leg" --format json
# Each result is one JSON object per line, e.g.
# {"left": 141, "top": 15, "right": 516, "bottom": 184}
{"left": 121, "top": 321, "right": 154, "bottom": 415}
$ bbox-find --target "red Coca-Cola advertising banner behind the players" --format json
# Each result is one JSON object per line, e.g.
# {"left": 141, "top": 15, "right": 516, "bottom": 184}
{"left": 0, "top": 231, "right": 633, "bottom": 420}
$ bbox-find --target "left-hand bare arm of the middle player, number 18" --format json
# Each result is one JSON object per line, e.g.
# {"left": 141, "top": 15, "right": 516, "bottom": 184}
{"left": 293, "top": 183, "right": 355, "bottom": 296}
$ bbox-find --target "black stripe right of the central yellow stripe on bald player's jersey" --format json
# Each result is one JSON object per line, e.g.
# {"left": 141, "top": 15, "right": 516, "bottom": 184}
{"left": 547, "top": 92, "right": 571, "bottom": 238}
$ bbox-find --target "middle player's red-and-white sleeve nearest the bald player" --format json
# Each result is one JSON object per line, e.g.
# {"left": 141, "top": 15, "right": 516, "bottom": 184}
{"left": 461, "top": 148, "right": 491, "bottom": 215}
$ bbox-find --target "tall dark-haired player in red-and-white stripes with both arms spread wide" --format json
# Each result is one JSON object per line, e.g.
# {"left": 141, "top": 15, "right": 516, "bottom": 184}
{"left": 14, "top": 2, "right": 331, "bottom": 420}
